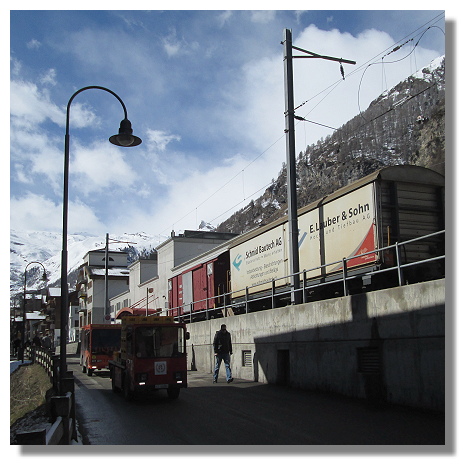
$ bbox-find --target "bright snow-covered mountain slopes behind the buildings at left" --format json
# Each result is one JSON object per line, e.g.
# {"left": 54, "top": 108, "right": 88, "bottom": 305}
{"left": 10, "top": 230, "right": 163, "bottom": 294}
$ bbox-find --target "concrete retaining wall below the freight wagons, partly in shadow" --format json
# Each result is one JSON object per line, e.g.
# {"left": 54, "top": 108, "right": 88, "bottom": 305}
{"left": 188, "top": 280, "right": 445, "bottom": 411}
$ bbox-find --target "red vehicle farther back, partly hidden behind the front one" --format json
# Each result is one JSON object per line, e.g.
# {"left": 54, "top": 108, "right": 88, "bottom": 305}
{"left": 80, "top": 324, "right": 121, "bottom": 375}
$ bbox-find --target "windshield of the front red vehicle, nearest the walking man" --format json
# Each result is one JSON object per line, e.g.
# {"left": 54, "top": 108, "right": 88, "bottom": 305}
{"left": 135, "top": 326, "right": 184, "bottom": 358}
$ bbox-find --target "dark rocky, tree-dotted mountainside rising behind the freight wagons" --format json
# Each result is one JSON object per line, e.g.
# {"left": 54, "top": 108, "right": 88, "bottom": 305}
{"left": 217, "top": 56, "right": 445, "bottom": 233}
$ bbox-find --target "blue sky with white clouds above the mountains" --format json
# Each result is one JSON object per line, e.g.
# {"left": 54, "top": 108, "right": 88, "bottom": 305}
{"left": 10, "top": 10, "right": 445, "bottom": 241}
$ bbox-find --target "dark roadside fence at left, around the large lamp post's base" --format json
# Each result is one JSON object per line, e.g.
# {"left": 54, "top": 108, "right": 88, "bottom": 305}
{"left": 16, "top": 346, "right": 77, "bottom": 445}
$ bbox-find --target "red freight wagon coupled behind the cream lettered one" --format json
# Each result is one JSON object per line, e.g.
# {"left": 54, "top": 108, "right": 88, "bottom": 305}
{"left": 168, "top": 250, "right": 230, "bottom": 320}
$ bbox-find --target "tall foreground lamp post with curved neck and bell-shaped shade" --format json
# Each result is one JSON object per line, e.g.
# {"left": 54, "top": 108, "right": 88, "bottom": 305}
{"left": 59, "top": 86, "right": 142, "bottom": 393}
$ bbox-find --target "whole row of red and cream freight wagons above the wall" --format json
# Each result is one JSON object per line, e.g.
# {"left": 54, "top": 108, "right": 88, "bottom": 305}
{"left": 169, "top": 165, "right": 444, "bottom": 318}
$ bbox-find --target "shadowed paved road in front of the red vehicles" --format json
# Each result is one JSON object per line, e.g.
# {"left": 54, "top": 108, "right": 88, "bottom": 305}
{"left": 69, "top": 359, "right": 445, "bottom": 450}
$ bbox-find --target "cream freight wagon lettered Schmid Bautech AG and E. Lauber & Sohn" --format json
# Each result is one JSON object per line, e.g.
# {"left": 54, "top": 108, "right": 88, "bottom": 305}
{"left": 230, "top": 165, "right": 444, "bottom": 301}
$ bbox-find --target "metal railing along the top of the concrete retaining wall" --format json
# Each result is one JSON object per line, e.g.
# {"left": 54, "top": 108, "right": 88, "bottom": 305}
{"left": 167, "top": 230, "right": 445, "bottom": 322}
